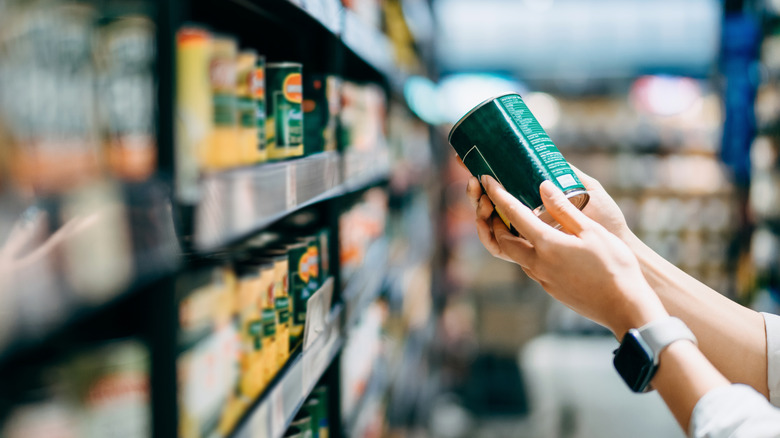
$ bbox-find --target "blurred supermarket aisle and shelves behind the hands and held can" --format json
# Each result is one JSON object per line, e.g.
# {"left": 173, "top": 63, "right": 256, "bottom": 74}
{"left": 0, "top": 0, "right": 780, "bottom": 438}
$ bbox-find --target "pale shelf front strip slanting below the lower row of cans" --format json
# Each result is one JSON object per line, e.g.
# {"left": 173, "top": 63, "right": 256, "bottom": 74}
{"left": 231, "top": 305, "right": 343, "bottom": 438}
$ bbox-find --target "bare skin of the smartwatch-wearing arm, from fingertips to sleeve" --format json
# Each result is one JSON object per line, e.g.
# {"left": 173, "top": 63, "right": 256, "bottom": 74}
{"left": 480, "top": 178, "right": 732, "bottom": 430}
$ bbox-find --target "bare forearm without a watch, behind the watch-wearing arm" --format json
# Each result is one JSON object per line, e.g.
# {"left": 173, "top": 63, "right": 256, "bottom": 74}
{"left": 624, "top": 235, "right": 769, "bottom": 397}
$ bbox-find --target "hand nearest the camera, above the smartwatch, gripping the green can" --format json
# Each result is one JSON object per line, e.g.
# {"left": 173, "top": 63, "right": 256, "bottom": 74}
{"left": 478, "top": 176, "right": 668, "bottom": 338}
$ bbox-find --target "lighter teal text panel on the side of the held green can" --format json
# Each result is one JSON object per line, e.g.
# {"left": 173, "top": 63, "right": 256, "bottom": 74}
{"left": 496, "top": 95, "right": 583, "bottom": 191}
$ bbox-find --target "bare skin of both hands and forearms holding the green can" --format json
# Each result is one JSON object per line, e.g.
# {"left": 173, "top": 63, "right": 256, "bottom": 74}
{"left": 467, "top": 172, "right": 752, "bottom": 430}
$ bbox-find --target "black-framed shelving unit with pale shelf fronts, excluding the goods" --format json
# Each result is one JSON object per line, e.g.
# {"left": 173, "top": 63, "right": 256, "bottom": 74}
{"left": 0, "top": 0, "right": 432, "bottom": 438}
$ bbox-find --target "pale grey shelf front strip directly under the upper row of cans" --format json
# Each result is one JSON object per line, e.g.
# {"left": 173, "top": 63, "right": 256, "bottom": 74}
{"left": 194, "top": 152, "right": 341, "bottom": 251}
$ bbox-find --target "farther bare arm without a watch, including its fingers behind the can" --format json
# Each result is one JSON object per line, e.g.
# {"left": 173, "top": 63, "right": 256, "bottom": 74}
{"left": 467, "top": 173, "right": 769, "bottom": 396}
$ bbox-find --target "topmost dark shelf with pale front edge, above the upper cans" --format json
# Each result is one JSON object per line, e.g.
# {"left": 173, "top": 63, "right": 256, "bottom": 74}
{"left": 193, "top": 0, "right": 408, "bottom": 102}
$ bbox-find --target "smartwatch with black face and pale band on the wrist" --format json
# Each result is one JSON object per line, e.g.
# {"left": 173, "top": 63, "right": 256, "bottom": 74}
{"left": 612, "top": 316, "right": 698, "bottom": 392}
